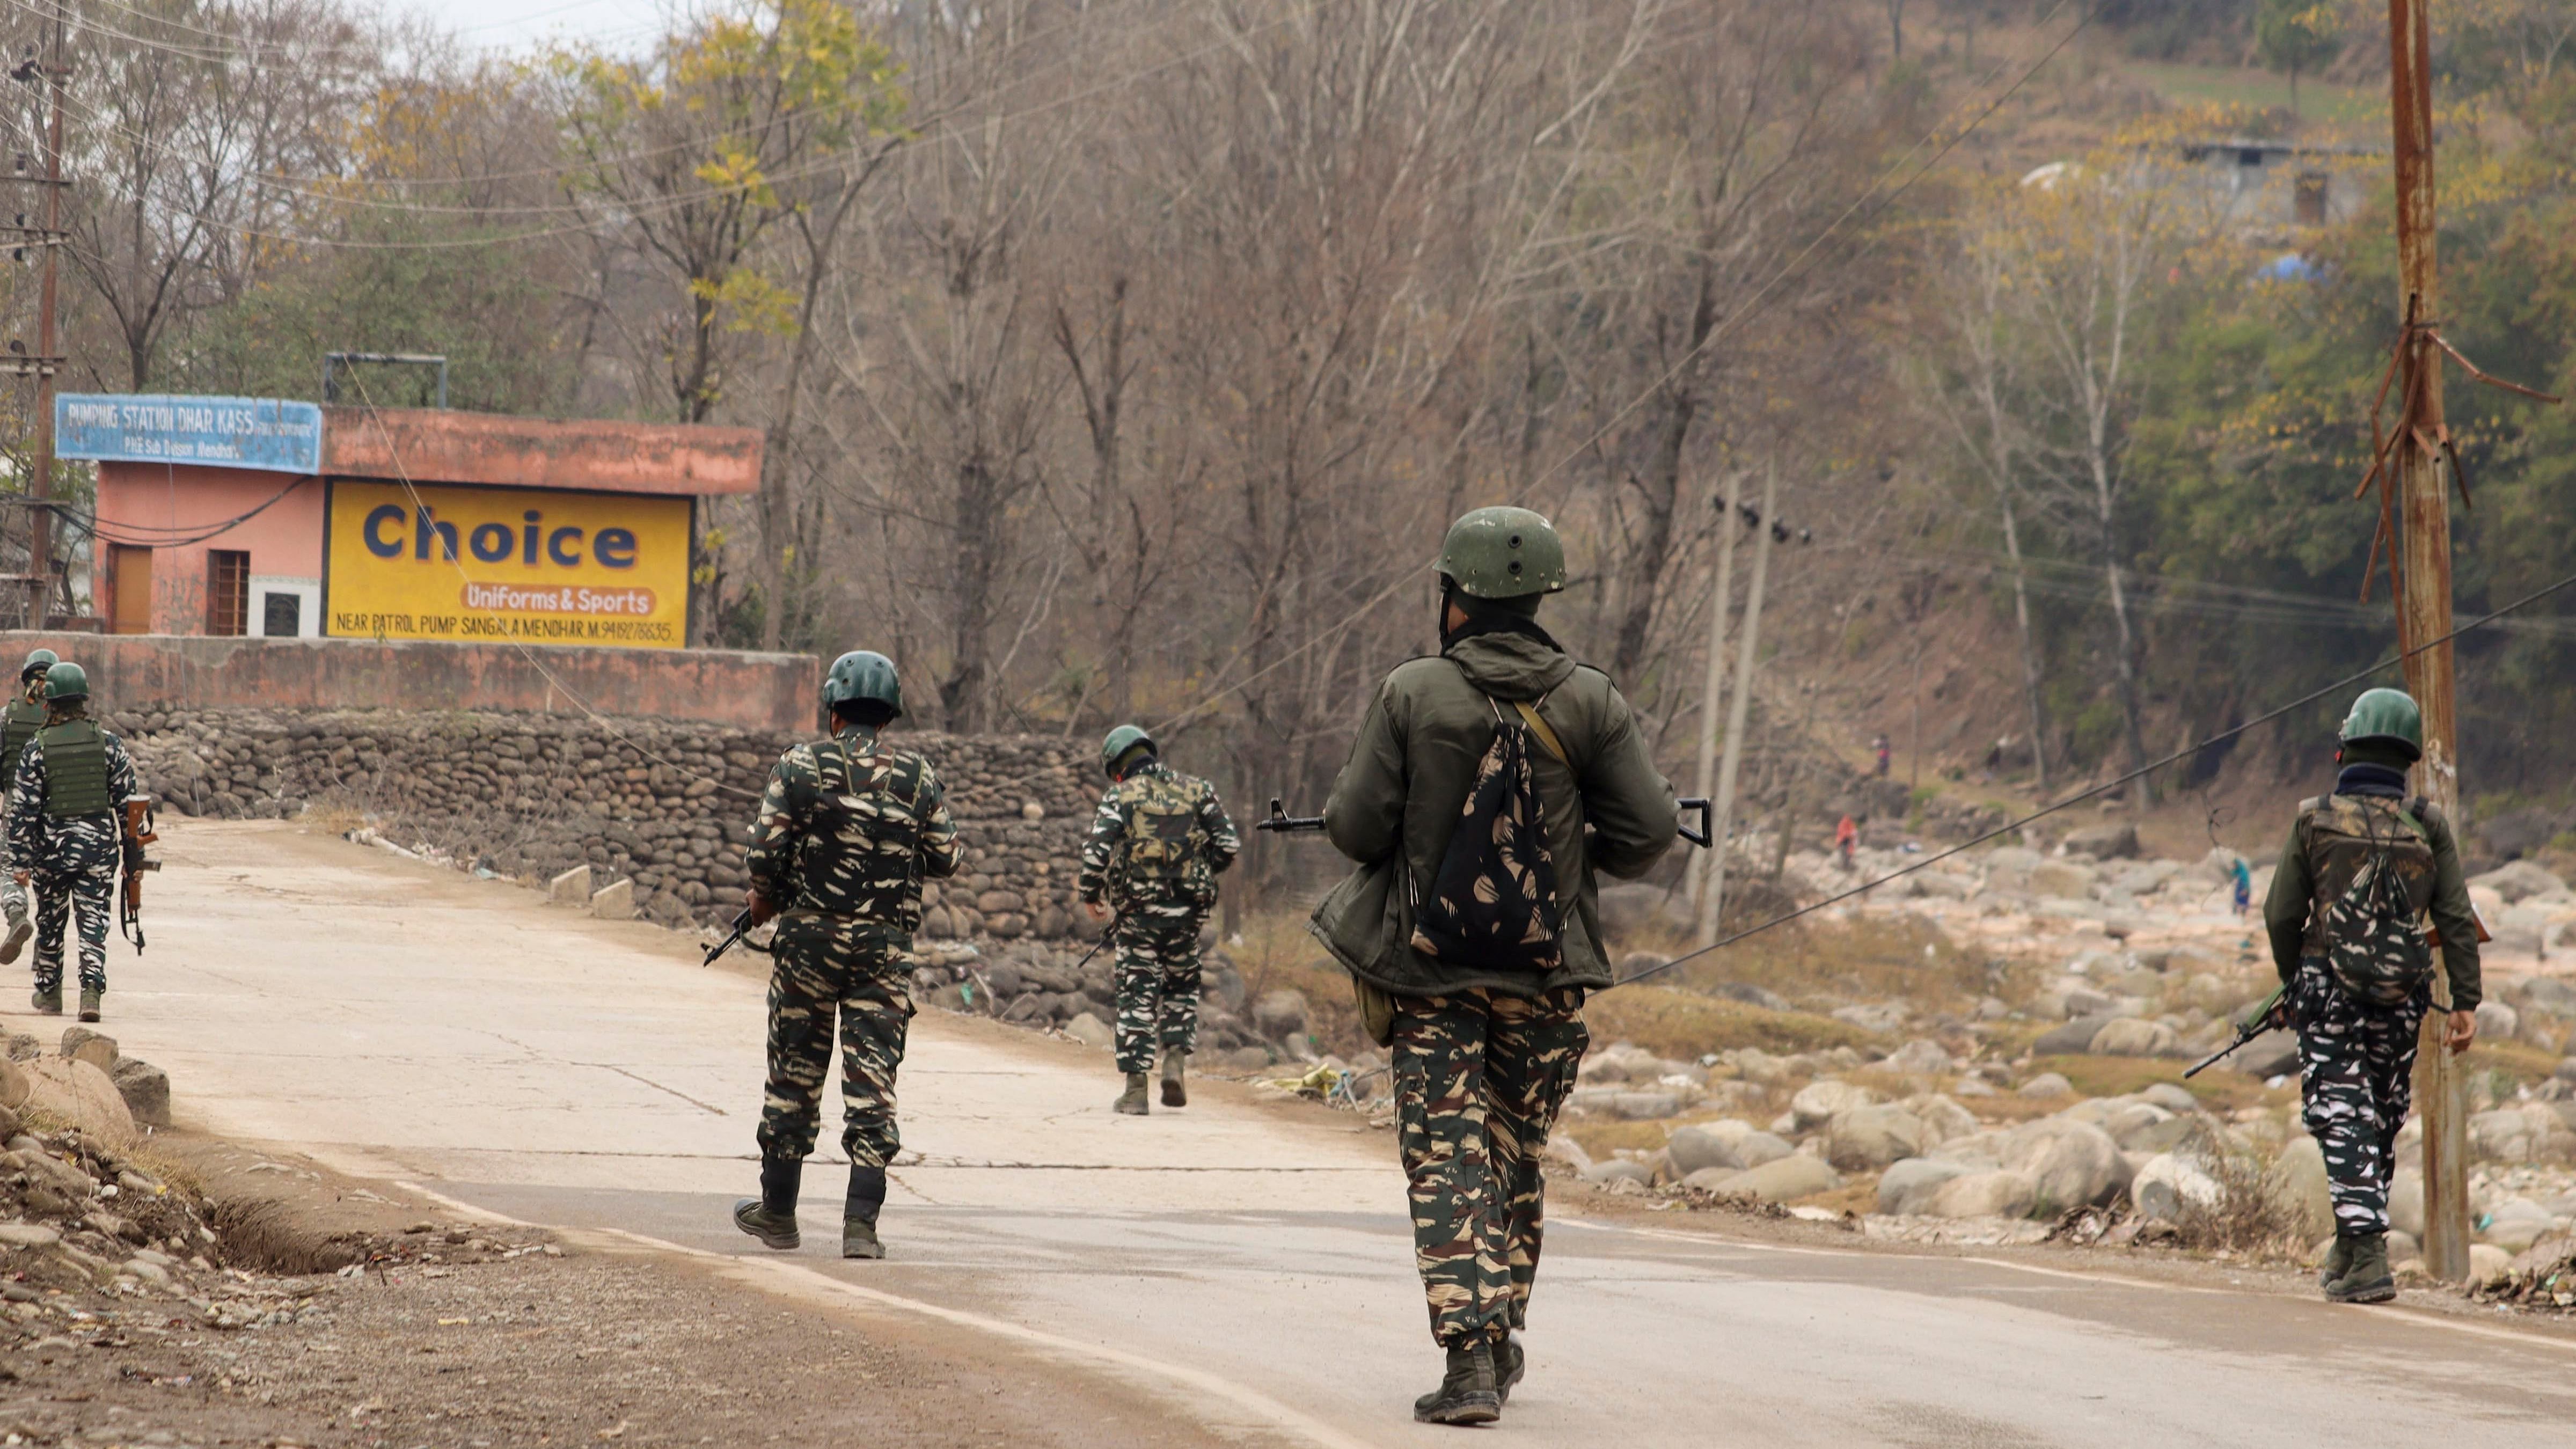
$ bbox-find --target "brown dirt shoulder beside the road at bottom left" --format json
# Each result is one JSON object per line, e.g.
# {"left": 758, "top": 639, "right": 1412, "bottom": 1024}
{"left": 0, "top": 1132, "right": 1247, "bottom": 1449}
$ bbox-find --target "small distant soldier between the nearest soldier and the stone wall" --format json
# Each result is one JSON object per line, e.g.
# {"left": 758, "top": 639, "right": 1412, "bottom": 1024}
{"left": 1077, "top": 724, "right": 1244, "bottom": 1116}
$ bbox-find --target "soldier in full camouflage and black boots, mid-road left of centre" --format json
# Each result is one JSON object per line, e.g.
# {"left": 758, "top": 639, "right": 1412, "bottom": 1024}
{"left": 734, "top": 650, "right": 958, "bottom": 1258}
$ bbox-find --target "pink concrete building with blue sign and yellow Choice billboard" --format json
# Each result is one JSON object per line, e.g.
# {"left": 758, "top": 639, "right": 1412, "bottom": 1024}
{"left": 57, "top": 394, "right": 760, "bottom": 647}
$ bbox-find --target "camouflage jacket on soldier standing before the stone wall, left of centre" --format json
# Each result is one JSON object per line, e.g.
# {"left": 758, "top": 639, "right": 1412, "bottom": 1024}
{"left": 742, "top": 727, "right": 958, "bottom": 933}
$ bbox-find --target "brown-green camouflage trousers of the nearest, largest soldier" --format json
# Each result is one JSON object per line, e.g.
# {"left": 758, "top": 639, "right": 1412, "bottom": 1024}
{"left": 1394, "top": 987, "right": 1592, "bottom": 1349}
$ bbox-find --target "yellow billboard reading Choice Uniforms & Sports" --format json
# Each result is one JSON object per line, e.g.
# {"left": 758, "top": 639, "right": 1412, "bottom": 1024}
{"left": 322, "top": 480, "right": 690, "bottom": 650}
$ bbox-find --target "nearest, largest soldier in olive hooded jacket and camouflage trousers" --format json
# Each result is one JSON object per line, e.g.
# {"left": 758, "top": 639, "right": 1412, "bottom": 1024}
{"left": 1314, "top": 508, "right": 1680, "bottom": 1423}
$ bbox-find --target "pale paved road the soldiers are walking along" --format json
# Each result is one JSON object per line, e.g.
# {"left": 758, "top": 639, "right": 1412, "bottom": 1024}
{"left": 50, "top": 825, "right": 2576, "bottom": 1449}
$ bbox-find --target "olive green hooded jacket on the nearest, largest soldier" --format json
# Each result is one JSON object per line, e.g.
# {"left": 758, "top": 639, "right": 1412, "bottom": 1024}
{"left": 1308, "top": 634, "right": 1680, "bottom": 995}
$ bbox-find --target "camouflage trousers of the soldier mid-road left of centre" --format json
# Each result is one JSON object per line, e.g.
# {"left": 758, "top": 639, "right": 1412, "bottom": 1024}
{"left": 760, "top": 916, "right": 912, "bottom": 1168}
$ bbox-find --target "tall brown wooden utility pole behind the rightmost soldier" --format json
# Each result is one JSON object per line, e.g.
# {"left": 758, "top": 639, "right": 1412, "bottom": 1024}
{"left": 2388, "top": 0, "right": 2468, "bottom": 1282}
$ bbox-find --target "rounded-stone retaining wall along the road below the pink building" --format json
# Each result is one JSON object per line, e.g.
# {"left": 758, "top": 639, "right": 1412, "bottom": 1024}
{"left": 108, "top": 709, "right": 1097, "bottom": 941}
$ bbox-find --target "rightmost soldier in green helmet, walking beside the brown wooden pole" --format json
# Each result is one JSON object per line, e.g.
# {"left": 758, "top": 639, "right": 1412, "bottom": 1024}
{"left": 2262, "top": 689, "right": 2483, "bottom": 1302}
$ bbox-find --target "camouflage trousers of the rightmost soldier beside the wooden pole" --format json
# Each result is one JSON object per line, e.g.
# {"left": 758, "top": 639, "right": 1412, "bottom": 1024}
{"left": 2293, "top": 956, "right": 2432, "bottom": 1235}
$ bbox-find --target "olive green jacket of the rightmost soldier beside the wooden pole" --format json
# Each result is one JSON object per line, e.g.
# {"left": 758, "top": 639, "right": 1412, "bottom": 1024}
{"left": 2262, "top": 794, "right": 2486, "bottom": 1011}
